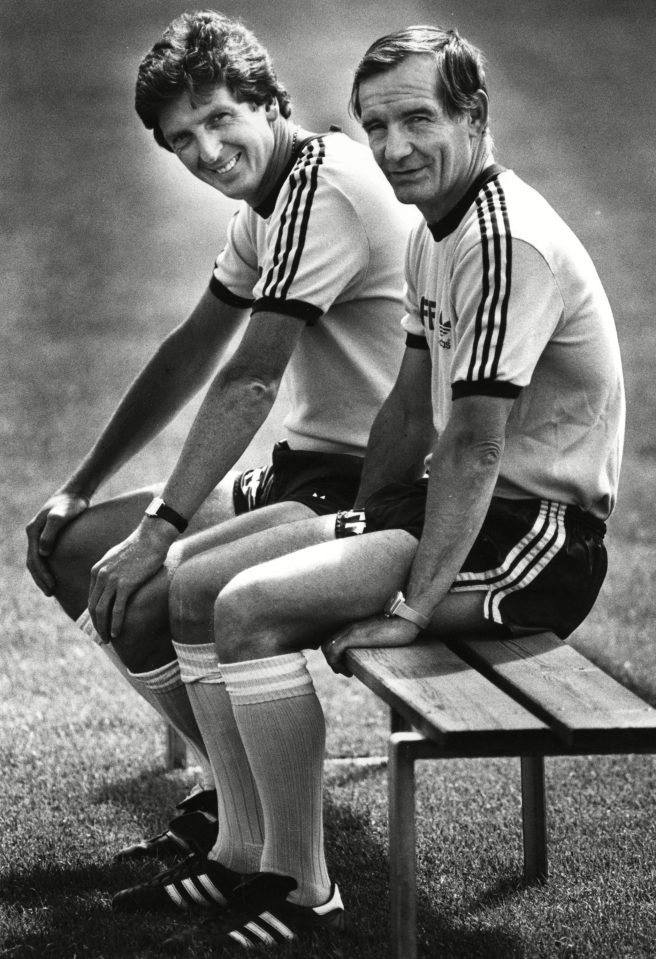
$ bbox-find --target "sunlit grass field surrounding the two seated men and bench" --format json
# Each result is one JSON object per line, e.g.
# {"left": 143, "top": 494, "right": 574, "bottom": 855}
{"left": 0, "top": 0, "right": 656, "bottom": 959}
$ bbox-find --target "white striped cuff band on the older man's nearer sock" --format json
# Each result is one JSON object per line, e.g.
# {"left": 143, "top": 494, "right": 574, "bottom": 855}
{"left": 221, "top": 653, "right": 314, "bottom": 706}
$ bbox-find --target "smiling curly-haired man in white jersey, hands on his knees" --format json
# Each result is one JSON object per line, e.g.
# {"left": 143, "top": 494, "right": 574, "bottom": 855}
{"left": 27, "top": 11, "right": 410, "bottom": 856}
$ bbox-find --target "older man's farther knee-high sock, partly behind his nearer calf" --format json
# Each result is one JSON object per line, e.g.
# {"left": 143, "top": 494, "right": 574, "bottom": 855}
{"left": 173, "top": 642, "right": 263, "bottom": 873}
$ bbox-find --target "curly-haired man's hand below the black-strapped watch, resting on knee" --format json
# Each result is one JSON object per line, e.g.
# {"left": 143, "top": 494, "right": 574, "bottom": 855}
{"left": 89, "top": 520, "right": 177, "bottom": 643}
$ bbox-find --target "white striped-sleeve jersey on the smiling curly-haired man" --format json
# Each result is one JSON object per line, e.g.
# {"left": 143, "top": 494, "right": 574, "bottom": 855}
{"left": 210, "top": 133, "right": 416, "bottom": 455}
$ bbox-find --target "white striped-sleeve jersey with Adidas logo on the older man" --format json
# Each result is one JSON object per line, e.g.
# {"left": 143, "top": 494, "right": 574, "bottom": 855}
{"left": 403, "top": 166, "right": 625, "bottom": 519}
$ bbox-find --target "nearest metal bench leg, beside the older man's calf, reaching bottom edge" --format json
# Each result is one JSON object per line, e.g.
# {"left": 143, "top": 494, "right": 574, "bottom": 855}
{"left": 388, "top": 734, "right": 417, "bottom": 959}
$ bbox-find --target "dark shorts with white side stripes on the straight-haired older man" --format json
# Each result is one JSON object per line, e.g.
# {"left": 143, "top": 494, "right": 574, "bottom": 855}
{"left": 336, "top": 480, "right": 608, "bottom": 639}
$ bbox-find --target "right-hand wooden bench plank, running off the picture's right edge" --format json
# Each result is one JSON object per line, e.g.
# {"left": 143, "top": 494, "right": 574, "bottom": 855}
{"left": 449, "top": 633, "right": 656, "bottom": 752}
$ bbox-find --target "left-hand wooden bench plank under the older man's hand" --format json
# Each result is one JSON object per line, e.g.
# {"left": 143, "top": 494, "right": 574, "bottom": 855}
{"left": 347, "top": 639, "right": 554, "bottom": 756}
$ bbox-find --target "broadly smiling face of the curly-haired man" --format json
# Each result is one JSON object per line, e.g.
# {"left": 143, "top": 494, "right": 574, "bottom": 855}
{"left": 158, "top": 85, "right": 278, "bottom": 202}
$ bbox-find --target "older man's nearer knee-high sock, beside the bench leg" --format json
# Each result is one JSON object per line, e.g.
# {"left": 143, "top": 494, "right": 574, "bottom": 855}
{"left": 221, "top": 653, "right": 330, "bottom": 906}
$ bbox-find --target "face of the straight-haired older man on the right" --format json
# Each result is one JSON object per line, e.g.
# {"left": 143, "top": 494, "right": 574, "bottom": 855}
{"left": 359, "top": 54, "right": 490, "bottom": 222}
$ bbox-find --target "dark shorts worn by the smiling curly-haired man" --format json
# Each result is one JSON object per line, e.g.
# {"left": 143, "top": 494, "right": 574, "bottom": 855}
{"left": 233, "top": 442, "right": 363, "bottom": 516}
